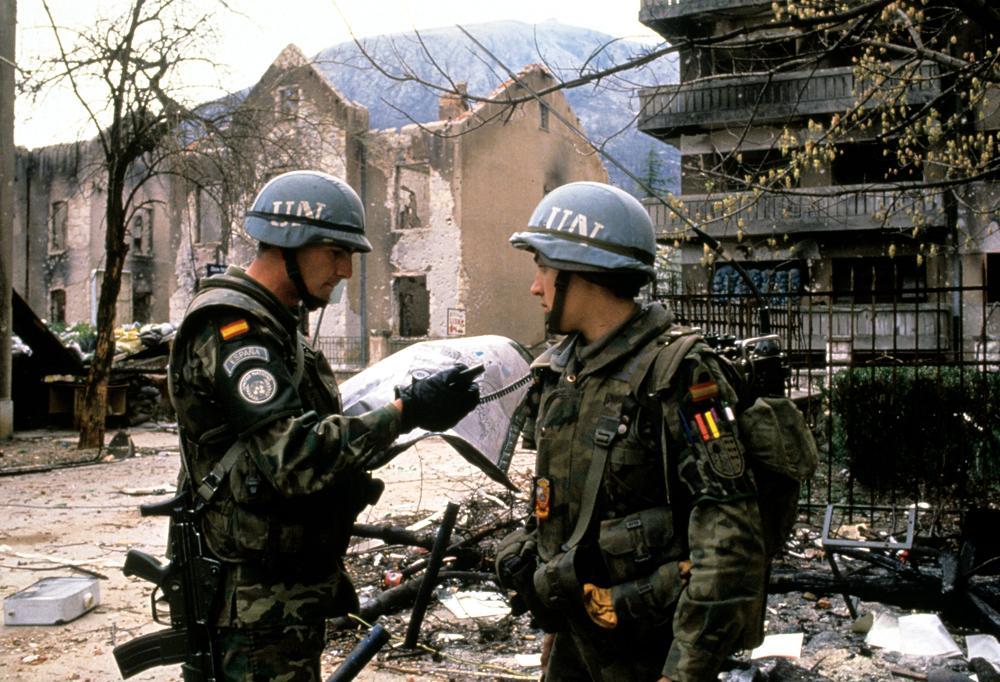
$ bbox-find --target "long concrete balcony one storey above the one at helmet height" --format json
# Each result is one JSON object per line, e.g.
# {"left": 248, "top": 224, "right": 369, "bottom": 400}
{"left": 638, "top": 63, "right": 941, "bottom": 138}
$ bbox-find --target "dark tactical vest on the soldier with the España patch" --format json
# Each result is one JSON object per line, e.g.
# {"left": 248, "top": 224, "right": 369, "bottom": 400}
{"left": 168, "top": 274, "right": 381, "bottom": 575}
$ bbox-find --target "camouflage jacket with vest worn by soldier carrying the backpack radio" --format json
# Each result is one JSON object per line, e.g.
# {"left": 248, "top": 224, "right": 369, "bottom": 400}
{"left": 532, "top": 304, "right": 765, "bottom": 680}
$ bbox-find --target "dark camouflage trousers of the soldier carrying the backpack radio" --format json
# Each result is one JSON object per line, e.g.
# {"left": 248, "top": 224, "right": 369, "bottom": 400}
{"left": 543, "top": 621, "right": 673, "bottom": 682}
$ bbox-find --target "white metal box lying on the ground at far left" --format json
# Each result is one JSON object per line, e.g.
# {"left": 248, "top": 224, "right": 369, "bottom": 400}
{"left": 3, "top": 577, "right": 101, "bottom": 625}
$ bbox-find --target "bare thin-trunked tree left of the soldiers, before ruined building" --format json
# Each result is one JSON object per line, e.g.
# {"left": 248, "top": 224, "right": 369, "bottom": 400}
{"left": 22, "top": 0, "right": 367, "bottom": 448}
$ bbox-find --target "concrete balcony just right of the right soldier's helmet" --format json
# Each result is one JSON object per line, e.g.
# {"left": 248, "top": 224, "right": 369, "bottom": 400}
{"left": 643, "top": 184, "right": 945, "bottom": 239}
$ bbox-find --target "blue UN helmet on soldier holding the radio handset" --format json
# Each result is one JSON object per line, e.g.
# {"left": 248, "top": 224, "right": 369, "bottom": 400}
{"left": 245, "top": 170, "right": 372, "bottom": 253}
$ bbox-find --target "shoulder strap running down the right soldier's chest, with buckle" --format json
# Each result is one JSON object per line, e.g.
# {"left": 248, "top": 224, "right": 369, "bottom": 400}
{"left": 562, "top": 327, "right": 701, "bottom": 552}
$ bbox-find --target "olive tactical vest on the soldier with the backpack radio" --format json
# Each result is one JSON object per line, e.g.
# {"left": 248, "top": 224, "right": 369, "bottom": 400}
{"left": 533, "top": 326, "right": 700, "bottom": 626}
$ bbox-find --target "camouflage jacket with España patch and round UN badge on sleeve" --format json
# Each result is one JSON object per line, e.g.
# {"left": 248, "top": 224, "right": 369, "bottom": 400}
{"left": 169, "top": 267, "right": 399, "bottom": 627}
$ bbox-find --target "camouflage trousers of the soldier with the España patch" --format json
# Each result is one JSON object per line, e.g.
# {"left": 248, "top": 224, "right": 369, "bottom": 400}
{"left": 217, "top": 621, "right": 326, "bottom": 682}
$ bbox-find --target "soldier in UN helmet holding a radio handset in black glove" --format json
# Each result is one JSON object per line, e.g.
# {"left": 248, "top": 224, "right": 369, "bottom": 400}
{"left": 170, "top": 171, "right": 478, "bottom": 681}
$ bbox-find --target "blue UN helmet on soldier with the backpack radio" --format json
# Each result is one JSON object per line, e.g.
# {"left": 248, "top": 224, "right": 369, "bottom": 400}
{"left": 510, "top": 182, "right": 656, "bottom": 281}
